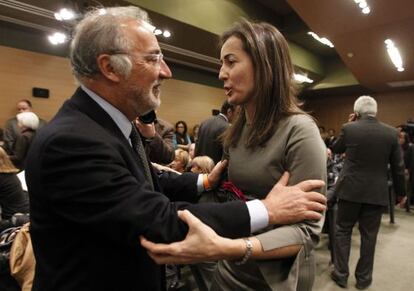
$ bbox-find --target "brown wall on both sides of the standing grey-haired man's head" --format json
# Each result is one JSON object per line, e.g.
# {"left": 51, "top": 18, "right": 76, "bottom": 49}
{"left": 306, "top": 89, "right": 414, "bottom": 133}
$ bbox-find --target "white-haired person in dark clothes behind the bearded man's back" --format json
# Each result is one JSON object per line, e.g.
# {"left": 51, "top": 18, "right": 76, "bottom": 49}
{"left": 10, "top": 112, "right": 39, "bottom": 169}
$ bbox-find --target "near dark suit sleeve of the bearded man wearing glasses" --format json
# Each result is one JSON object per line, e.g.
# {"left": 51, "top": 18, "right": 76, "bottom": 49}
{"left": 33, "top": 131, "right": 250, "bottom": 246}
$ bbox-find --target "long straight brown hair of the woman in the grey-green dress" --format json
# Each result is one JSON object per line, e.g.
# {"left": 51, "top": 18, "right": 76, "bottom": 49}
{"left": 220, "top": 19, "right": 304, "bottom": 148}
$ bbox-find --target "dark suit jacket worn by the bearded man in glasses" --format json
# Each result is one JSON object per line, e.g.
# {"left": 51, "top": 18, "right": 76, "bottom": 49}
{"left": 26, "top": 89, "right": 250, "bottom": 291}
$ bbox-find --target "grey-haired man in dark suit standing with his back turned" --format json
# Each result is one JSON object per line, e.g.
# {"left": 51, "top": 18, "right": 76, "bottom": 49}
{"left": 331, "top": 96, "right": 405, "bottom": 289}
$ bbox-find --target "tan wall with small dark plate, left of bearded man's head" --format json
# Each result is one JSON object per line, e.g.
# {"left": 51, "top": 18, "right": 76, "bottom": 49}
{"left": 0, "top": 46, "right": 76, "bottom": 127}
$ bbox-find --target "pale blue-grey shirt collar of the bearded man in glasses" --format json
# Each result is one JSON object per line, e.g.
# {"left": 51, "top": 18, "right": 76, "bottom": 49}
{"left": 81, "top": 85, "right": 132, "bottom": 141}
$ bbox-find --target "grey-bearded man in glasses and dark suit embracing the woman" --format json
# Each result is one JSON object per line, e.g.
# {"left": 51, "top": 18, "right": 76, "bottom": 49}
{"left": 26, "top": 7, "right": 325, "bottom": 291}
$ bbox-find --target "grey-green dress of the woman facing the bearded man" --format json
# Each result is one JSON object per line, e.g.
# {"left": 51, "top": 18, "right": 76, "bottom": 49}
{"left": 211, "top": 114, "right": 326, "bottom": 291}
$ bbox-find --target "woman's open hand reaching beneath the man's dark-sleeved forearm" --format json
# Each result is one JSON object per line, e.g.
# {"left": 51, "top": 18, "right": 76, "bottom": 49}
{"left": 140, "top": 210, "right": 234, "bottom": 264}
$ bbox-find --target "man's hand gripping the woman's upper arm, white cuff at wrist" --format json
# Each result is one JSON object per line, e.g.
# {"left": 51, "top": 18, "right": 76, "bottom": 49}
{"left": 262, "top": 172, "right": 326, "bottom": 224}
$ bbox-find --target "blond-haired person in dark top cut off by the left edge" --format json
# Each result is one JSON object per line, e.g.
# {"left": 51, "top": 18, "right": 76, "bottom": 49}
{"left": 0, "top": 147, "right": 29, "bottom": 230}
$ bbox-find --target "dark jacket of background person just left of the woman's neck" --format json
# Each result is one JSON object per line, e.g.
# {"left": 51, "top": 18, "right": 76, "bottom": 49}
{"left": 195, "top": 114, "right": 230, "bottom": 163}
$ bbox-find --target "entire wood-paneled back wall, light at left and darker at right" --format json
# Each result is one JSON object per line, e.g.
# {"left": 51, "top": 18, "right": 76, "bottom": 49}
{"left": 0, "top": 46, "right": 414, "bottom": 137}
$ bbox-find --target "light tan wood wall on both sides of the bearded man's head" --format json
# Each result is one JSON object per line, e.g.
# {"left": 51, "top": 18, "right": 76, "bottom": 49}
{"left": 0, "top": 46, "right": 224, "bottom": 132}
